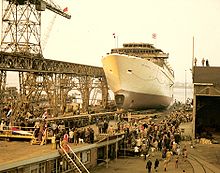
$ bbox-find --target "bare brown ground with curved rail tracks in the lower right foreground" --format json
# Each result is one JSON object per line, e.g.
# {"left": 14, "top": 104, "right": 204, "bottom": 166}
{"left": 91, "top": 142, "right": 220, "bottom": 173}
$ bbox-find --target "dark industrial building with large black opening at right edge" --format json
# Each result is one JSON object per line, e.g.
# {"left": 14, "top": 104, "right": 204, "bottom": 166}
{"left": 193, "top": 66, "right": 220, "bottom": 138}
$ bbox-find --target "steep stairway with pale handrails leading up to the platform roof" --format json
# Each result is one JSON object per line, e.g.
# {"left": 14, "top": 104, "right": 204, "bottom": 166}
{"left": 58, "top": 145, "right": 90, "bottom": 173}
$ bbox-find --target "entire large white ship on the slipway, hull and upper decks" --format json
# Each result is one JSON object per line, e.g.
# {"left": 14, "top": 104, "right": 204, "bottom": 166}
{"left": 102, "top": 43, "right": 174, "bottom": 110}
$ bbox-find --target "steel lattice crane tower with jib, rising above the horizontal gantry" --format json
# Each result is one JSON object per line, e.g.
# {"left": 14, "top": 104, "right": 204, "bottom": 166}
{"left": 1, "top": 0, "right": 71, "bottom": 54}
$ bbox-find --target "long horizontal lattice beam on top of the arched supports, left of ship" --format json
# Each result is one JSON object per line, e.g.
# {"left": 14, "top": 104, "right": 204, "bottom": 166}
{"left": 0, "top": 52, "right": 105, "bottom": 78}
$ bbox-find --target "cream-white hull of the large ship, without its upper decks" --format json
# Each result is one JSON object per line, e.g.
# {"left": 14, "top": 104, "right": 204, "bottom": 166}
{"left": 102, "top": 54, "right": 174, "bottom": 110}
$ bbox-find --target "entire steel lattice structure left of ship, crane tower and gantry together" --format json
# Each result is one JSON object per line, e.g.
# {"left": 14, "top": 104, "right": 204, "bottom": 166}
{"left": 0, "top": 0, "right": 108, "bottom": 119}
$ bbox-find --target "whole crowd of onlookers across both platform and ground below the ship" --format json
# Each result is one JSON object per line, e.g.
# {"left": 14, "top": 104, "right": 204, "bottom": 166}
{"left": 1, "top": 101, "right": 192, "bottom": 172}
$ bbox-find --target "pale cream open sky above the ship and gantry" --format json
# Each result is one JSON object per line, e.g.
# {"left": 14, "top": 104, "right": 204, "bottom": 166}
{"left": 2, "top": 0, "right": 220, "bottom": 85}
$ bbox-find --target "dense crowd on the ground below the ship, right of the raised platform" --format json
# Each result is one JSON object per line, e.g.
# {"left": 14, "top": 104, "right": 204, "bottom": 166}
{"left": 111, "top": 110, "right": 192, "bottom": 172}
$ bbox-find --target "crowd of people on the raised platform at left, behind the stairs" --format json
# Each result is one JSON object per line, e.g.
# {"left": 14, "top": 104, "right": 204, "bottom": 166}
{"left": 0, "top": 107, "right": 113, "bottom": 148}
